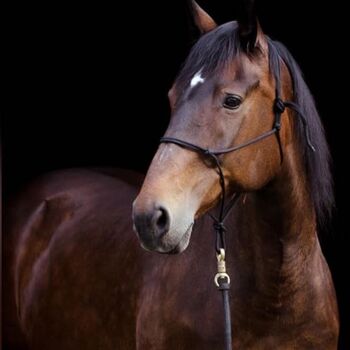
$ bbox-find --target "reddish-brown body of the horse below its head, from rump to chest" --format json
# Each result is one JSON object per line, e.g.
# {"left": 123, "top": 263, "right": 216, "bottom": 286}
{"left": 5, "top": 166, "right": 337, "bottom": 350}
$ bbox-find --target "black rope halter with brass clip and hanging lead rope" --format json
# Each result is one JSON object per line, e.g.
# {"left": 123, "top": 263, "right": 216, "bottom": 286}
{"left": 160, "top": 94, "right": 315, "bottom": 350}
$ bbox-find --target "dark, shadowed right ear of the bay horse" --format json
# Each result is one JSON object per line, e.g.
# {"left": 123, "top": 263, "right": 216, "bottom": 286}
{"left": 237, "top": 0, "right": 259, "bottom": 51}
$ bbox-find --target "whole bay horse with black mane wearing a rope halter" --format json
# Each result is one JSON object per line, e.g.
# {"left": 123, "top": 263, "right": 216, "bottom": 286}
{"left": 3, "top": 1, "right": 339, "bottom": 350}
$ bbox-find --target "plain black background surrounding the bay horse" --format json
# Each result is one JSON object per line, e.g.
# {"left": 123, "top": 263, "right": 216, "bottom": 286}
{"left": 2, "top": 0, "right": 350, "bottom": 349}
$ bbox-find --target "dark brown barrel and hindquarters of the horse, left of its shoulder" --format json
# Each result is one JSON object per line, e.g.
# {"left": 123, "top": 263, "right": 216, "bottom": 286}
{"left": 3, "top": 169, "right": 142, "bottom": 349}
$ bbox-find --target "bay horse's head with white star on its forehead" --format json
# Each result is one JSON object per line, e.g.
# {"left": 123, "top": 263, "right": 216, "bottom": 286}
{"left": 133, "top": 1, "right": 328, "bottom": 253}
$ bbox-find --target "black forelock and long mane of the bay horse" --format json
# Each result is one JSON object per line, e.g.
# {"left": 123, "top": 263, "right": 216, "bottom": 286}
{"left": 176, "top": 22, "right": 334, "bottom": 225}
